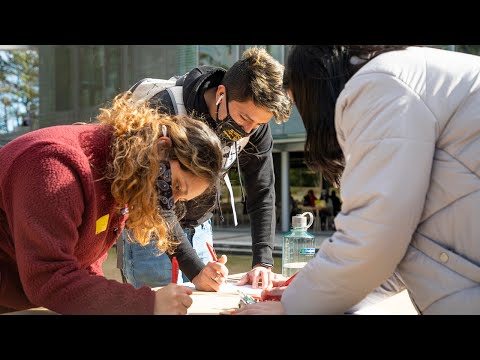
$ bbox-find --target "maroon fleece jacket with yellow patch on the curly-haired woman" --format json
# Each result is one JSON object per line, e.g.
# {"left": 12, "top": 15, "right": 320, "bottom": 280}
{"left": 0, "top": 125, "right": 155, "bottom": 314}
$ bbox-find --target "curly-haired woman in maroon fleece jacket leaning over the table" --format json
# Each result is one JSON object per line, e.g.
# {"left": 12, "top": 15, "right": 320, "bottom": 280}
{"left": 0, "top": 94, "right": 224, "bottom": 314}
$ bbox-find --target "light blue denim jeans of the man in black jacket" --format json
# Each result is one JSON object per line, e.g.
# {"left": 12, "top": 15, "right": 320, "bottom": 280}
{"left": 122, "top": 220, "right": 213, "bottom": 288}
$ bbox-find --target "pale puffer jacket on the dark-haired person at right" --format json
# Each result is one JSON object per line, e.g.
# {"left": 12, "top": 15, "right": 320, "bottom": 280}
{"left": 282, "top": 47, "right": 480, "bottom": 314}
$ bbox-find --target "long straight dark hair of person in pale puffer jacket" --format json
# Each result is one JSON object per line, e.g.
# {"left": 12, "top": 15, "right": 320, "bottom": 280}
{"left": 284, "top": 45, "right": 409, "bottom": 185}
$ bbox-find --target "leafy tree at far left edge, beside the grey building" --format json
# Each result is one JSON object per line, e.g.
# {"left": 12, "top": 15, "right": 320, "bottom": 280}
{"left": 0, "top": 50, "right": 39, "bottom": 131}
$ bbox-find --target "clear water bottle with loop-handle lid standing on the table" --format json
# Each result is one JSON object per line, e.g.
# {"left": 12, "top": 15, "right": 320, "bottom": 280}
{"left": 282, "top": 212, "right": 315, "bottom": 276}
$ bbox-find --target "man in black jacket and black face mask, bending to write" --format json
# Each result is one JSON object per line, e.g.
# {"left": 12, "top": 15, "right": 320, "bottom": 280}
{"left": 119, "top": 48, "right": 292, "bottom": 291}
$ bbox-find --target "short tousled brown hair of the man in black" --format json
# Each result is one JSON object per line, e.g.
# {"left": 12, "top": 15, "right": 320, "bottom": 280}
{"left": 222, "top": 48, "right": 292, "bottom": 124}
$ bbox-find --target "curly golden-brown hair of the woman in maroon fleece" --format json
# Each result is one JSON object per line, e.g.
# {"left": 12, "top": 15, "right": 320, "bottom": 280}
{"left": 97, "top": 92, "right": 222, "bottom": 253}
